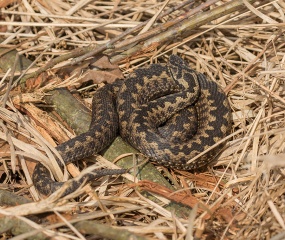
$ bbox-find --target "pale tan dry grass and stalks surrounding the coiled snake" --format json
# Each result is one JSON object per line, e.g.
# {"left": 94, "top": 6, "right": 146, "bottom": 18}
{"left": 0, "top": 0, "right": 285, "bottom": 239}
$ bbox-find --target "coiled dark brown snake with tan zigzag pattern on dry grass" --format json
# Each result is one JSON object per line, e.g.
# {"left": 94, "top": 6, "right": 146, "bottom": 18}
{"left": 33, "top": 55, "right": 231, "bottom": 195}
